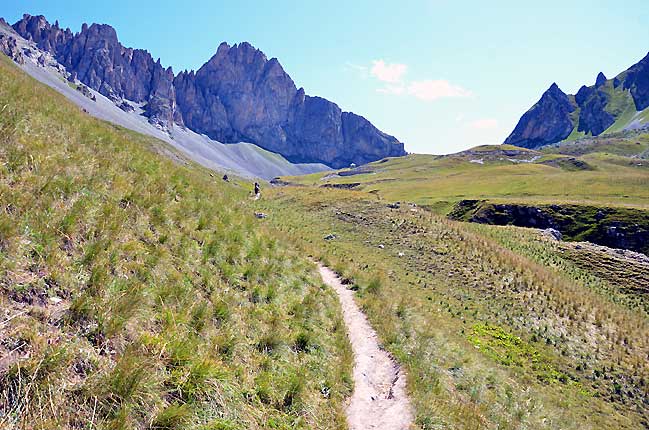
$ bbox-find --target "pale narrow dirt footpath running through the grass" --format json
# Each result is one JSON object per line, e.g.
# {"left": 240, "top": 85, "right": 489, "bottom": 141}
{"left": 318, "top": 265, "right": 413, "bottom": 430}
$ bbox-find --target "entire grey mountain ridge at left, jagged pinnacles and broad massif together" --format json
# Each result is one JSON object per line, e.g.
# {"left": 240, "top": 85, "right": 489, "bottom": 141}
{"left": 13, "top": 15, "right": 406, "bottom": 167}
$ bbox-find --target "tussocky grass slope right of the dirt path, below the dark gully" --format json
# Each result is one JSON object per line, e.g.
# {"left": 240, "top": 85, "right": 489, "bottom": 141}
{"left": 257, "top": 189, "right": 649, "bottom": 429}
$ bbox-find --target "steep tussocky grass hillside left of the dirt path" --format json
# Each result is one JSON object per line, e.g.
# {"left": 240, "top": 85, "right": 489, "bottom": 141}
{"left": 0, "top": 55, "right": 351, "bottom": 429}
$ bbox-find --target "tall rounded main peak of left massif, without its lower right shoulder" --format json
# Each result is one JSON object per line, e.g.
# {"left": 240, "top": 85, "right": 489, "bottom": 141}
{"left": 174, "top": 43, "right": 297, "bottom": 145}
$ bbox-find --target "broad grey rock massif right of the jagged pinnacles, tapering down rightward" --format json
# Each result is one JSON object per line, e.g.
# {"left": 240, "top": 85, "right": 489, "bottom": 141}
{"left": 174, "top": 43, "right": 405, "bottom": 167}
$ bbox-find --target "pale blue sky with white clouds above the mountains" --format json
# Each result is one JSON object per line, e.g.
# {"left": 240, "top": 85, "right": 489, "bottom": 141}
{"left": 0, "top": 0, "right": 649, "bottom": 153}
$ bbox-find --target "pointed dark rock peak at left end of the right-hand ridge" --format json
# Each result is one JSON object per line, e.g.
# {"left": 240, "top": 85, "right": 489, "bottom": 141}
{"left": 505, "top": 83, "right": 575, "bottom": 148}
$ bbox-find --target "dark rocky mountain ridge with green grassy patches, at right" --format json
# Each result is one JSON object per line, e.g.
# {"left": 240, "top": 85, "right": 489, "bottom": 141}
{"left": 504, "top": 54, "right": 649, "bottom": 148}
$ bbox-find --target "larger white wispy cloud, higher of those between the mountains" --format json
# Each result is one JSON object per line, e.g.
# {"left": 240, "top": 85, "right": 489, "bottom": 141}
{"left": 364, "top": 60, "right": 472, "bottom": 101}
